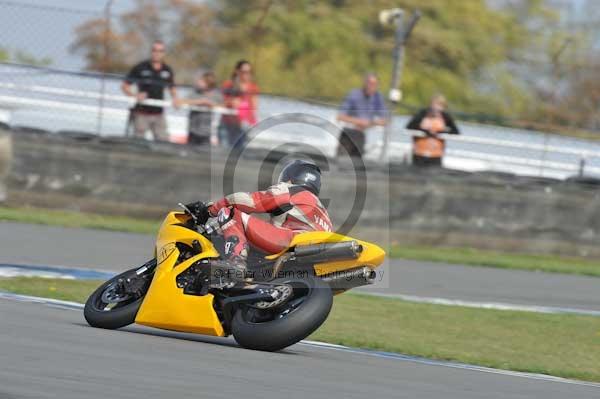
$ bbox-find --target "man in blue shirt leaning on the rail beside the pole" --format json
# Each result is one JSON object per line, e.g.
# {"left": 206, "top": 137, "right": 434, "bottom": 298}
{"left": 337, "top": 74, "right": 387, "bottom": 157}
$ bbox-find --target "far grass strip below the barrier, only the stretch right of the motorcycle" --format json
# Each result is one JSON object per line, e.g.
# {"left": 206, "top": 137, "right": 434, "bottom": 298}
{"left": 390, "top": 246, "right": 600, "bottom": 277}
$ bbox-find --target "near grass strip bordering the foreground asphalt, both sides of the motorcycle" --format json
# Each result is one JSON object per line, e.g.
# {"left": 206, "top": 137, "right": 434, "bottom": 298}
{"left": 0, "top": 277, "right": 600, "bottom": 381}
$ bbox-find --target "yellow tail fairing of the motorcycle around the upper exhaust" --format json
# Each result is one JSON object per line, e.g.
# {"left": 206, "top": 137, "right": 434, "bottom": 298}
{"left": 267, "top": 231, "right": 385, "bottom": 276}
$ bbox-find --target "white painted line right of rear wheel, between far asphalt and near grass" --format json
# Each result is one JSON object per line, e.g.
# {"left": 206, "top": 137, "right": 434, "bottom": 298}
{"left": 354, "top": 291, "right": 600, "bottom": 317}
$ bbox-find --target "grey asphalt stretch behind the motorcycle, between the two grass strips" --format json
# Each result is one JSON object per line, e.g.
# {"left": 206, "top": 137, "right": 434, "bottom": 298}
{"left": 0, "top": 222, "right": 600, "bottom": 310}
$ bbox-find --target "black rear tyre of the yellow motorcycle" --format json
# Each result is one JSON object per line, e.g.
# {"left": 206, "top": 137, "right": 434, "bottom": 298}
{"left": 231, "top": 277, "right": 333, "bottom": 352}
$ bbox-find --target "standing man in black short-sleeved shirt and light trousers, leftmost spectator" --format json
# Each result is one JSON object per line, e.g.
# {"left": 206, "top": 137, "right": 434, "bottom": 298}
{"left": 121, "top": 40, "right": 177, "bottom": 141}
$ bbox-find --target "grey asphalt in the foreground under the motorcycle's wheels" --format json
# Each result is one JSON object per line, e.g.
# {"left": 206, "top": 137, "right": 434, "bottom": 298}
{"left": 0, "top": 299, "right": 600, "bottom": 399}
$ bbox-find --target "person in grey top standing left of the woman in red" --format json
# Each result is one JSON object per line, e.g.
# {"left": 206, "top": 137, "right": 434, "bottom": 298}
{"left": 177, "top": 71, "right": 223, "bottom": 145}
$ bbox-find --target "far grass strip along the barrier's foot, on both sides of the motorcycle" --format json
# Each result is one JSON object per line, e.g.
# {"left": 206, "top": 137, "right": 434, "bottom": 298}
{"left": 0, "top": 207, "right": 600, "bottom": 277}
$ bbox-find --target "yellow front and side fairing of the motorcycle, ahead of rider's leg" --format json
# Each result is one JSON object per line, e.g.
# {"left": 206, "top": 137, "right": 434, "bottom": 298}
{"left": 135, "top": 212, "right": 225, "bottom": 337}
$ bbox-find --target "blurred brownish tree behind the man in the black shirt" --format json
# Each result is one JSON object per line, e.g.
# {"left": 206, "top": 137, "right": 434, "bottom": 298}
{"left": 70, "top": 0, "right": 218, "bottom": 78}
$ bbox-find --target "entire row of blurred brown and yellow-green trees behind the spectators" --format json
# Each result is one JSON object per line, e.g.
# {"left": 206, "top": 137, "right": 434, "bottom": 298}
{"left": 72, "top": 0, "right": 555, "bottom": 122}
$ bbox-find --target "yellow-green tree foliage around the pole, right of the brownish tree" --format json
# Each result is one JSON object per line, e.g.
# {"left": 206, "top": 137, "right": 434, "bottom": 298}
{"left": 212, "top": 0, "right": 553, "bottom": 115}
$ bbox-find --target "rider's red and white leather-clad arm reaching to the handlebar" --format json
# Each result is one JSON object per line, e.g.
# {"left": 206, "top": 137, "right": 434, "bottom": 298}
{"left": 209, "top": 184, "right": 290, "bottom": 215}
